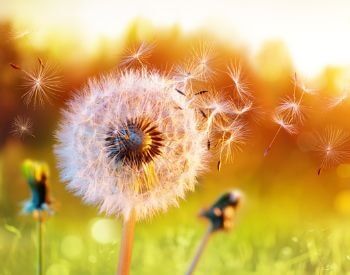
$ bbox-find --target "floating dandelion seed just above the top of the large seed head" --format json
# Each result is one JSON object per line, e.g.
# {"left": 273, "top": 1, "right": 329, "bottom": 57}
{"left": 120, "top": 42, "right": 155, "bottom": 68}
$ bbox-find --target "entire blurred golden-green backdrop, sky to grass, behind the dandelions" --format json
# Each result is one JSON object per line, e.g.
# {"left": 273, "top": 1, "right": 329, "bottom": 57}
{"left": 0, "top": 0, "right": 350, "bottom": 275}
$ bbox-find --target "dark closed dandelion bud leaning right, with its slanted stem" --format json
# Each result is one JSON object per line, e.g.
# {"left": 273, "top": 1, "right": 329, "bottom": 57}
{"left": 186, "top": 190, "right": 242, "bottom": 275}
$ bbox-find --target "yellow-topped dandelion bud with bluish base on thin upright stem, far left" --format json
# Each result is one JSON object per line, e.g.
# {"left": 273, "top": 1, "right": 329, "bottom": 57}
{"left": 22, "top": 159, "right": 53, "bottom": 275}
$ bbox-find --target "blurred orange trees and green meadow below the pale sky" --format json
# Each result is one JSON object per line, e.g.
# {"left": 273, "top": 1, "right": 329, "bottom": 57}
{"left": 0, "top": 20, "right": 350, "bottom": 275}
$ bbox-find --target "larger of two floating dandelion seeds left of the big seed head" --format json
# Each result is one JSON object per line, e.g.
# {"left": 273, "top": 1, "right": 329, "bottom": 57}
{"left": 10, "top": 58, "right": 61, "bottom": 106}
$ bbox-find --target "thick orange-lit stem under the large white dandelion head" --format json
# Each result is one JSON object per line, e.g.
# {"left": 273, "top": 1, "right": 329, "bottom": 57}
{"left": 117, "top": 210, "right": 136, "bottom": 275}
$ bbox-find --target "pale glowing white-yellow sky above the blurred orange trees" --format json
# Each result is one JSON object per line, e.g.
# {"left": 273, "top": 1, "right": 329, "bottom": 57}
{"left": 0, "top": 0, "right": 350, "bottom": 76}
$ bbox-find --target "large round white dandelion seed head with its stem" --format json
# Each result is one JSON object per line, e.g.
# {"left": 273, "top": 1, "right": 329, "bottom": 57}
{"left": 55, "top": 70, "right": 208, "bottom": 274}
